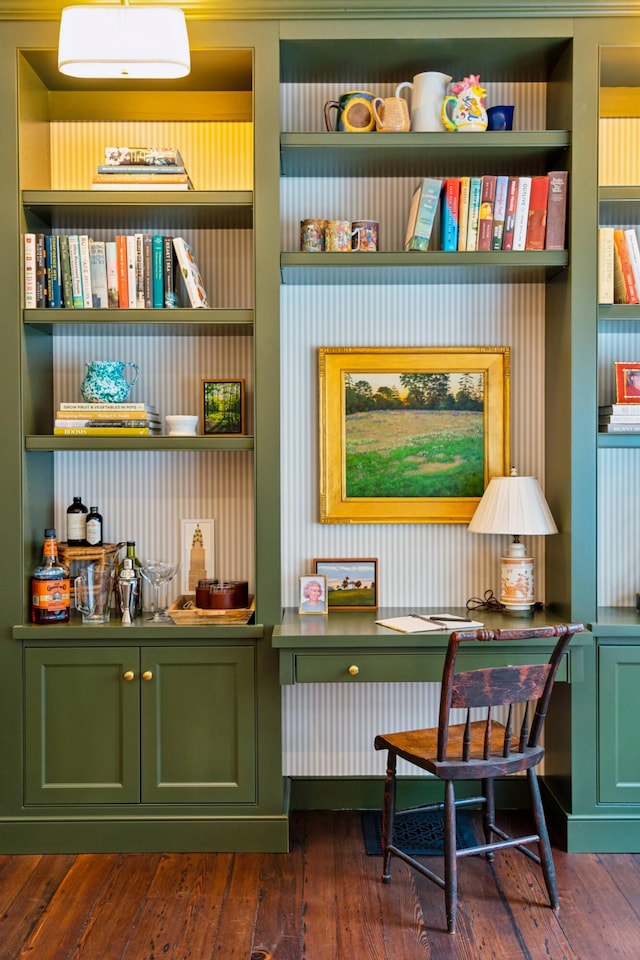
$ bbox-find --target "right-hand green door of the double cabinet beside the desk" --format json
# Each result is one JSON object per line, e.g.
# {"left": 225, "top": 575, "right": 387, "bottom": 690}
{"left": 140, "top": 646, "right": 256, "bottom": 803}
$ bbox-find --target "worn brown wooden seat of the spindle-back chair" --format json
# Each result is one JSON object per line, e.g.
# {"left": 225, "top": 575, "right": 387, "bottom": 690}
{"left": 374, "top": 720, "right": 544, "bottom": 780}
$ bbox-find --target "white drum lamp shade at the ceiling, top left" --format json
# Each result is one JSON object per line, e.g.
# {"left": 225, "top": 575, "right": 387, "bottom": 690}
{"left": 58, "top": 4, "right": 191, "bottom": 80}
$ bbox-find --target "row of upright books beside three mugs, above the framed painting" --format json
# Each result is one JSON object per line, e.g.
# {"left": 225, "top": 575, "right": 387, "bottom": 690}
{"left": 405, "top": 170, "right": 568, "bottom": 252}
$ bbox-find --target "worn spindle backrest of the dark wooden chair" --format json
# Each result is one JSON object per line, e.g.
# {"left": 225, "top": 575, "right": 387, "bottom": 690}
{"left": 438, "top": 623, "right": 584, "bottom": 761}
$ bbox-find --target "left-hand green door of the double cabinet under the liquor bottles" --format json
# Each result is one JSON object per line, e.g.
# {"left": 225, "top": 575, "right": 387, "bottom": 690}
{"left": 25, "top": 647, "right": 140, "bottom": 804}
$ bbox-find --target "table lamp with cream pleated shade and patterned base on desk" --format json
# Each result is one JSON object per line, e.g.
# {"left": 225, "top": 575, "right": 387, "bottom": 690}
{"left": 469, "top": 468, "right": 558, "bottom": 617}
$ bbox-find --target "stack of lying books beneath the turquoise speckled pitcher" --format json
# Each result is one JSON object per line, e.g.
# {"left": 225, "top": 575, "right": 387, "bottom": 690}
{"left": 53, "top": 403, "right": 160, "bottom": 437}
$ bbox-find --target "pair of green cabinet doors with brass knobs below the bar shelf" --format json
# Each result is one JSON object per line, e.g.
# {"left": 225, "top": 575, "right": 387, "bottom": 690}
{"left": 25, "top": 646, "right": 256, "bottom": 805}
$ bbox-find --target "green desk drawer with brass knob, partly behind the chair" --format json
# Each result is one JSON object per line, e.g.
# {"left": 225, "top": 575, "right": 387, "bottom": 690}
{"left": 294, "top": 649, "right": 567, "bottom": 683}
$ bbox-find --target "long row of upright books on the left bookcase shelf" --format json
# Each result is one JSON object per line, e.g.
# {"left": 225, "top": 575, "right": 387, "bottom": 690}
{"left": 24, "top": 233, "right": 209, "bottom": 310}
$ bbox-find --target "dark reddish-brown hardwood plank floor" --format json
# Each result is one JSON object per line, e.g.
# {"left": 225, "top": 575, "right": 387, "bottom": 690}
{"left": 0, "top": 812, "right": 640, "bottom": 960}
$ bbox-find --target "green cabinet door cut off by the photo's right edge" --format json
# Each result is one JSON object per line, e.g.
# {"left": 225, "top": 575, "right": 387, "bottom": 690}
{"left": 598, "top": 646, "right": 640, "bottom": 803}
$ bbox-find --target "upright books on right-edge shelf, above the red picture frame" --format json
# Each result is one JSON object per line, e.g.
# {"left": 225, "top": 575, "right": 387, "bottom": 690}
{"left": 598, "top": 227, "right": 640, "bottom": 303}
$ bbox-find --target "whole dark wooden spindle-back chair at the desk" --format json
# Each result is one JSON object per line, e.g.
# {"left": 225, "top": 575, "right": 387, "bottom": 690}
{"left": 375, "top": 623, "right": 584, "bottom": 933}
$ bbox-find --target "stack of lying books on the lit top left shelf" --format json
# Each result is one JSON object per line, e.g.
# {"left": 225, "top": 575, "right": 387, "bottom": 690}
{"left": 91, "top": 147, "right": 193, "bottom": 190}
